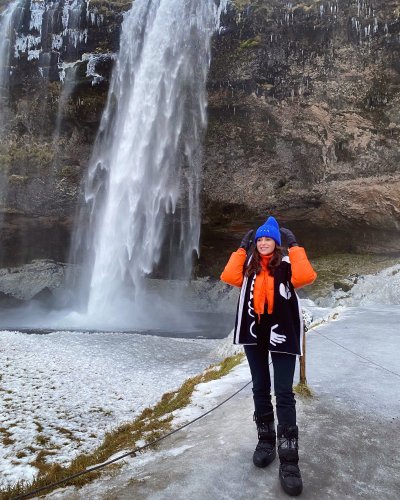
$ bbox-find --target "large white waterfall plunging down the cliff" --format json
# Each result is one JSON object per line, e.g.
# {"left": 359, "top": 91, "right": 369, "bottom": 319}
{"left": 72, "top": 0, "right": 227, "bottom": 319}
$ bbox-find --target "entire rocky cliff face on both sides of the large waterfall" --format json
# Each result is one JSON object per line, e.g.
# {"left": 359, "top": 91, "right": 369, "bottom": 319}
{"left": 0, "top": 0, "right": 400, "bottom": 272}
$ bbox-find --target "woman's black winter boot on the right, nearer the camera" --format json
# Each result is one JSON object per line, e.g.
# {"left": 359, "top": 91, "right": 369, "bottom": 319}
{"left": 278, "top": 425, "right": 303, "bottom": 497}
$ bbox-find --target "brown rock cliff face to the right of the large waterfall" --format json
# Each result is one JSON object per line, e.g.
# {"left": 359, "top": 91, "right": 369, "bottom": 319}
{"left": 204, "top": 0, "right": 400, "bottom": 258}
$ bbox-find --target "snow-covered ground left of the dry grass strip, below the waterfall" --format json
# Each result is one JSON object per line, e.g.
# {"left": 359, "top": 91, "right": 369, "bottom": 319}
{"left": 0, "top": 331, "right": 218, "bottom": 484}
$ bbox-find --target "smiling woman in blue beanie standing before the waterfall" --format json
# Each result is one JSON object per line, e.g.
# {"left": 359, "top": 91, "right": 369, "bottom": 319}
{"left": 221, "top": 217, "right": 317, "bottom": 496}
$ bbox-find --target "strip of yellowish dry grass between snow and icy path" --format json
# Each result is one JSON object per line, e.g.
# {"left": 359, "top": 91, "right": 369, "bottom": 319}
{"left": 0, "top": 354, "right": 243, "bottom": 500}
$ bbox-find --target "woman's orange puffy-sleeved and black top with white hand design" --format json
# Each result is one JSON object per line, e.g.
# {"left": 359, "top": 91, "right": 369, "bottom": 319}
{"left": 221, "top": 247, "right": 317, "bottom": 355}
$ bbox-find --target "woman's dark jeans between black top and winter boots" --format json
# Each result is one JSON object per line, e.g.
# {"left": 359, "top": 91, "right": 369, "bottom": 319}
{"left": 244, "top": 343, "right": 296, "bottom": 425}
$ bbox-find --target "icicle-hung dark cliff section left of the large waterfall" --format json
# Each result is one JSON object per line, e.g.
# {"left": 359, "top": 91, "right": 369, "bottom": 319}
{"left": 0, "top": 0, "right": 126, "bottom": 265}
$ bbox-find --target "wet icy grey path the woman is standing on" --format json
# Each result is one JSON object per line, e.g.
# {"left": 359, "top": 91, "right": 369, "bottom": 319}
{"left": 49, "top": 306, "right": 400, "bottom": 500}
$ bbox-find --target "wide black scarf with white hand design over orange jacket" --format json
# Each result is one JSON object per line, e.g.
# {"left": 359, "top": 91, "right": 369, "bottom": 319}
{"left": 234, "top": 257, "right": 304, "bottom": 355}
